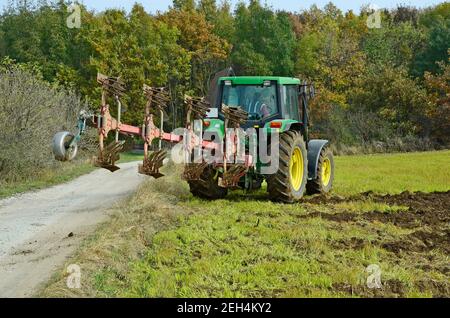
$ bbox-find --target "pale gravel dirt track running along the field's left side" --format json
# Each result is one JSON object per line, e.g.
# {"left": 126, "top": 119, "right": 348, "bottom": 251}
{"left": 0, "top": 162, "right": 145, "bottom": 297}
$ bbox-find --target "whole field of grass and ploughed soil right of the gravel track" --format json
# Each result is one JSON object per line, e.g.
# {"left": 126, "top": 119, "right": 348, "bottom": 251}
{"left": 40, "top": 151, "right": 450, "bottom": 297}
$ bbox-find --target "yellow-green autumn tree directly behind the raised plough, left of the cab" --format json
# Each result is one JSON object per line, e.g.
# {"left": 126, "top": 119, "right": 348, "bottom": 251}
{"left": 79, "top": 5, "right": 190, "bottom": 124}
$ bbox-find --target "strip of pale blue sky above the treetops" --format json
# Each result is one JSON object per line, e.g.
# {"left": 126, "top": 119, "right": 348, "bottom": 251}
{"left": 0, "top": 0, "right": 445, "bottom": 13}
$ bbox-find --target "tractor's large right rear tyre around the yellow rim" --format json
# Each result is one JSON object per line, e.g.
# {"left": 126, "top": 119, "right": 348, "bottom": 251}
{"left": 266, "top": 131, "right": 308, "bottom": 203}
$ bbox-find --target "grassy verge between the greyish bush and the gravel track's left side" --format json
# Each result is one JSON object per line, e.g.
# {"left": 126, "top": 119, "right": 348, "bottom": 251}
{"left": 0, "top": 153, "right": 143, "bottom": 199}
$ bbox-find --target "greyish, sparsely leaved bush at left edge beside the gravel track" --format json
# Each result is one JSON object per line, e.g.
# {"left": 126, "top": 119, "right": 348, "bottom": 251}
{"left": 0, "top": 66, "right": 89, "bottom": 183}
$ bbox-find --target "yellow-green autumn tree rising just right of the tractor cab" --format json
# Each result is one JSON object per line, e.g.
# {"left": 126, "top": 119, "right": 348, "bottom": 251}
{"left": 295, "top": 4, "right": 366, "bottom": 122}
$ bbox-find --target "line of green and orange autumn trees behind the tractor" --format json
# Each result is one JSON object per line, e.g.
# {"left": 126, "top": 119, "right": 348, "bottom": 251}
{"left": 0, "top": 0, "right": 450, "bottom": 151}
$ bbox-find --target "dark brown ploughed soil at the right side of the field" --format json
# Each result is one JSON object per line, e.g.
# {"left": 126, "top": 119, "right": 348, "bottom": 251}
{"left": 299, "top": 191, "right": 450, "bottom": 297}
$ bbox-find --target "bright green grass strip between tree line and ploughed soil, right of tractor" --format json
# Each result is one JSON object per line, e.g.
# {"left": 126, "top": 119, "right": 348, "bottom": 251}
{"left": 334, "top": 150, "right": 450, "bottom": 195}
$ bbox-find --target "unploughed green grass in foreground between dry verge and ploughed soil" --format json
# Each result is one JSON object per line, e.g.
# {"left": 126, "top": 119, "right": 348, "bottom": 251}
{"left": 115, "top": 198, "right": 442, "bottom": 297}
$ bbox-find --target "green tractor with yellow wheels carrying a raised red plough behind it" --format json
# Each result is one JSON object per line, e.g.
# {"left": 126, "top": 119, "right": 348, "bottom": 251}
{"left": 53, "top": 74, "right": 334, "bottom": 203}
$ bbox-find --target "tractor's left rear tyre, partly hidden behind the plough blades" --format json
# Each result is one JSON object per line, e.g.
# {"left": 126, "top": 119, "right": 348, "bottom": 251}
{"left": 188, "top": 167, "right": 228, "bottom": 200}
